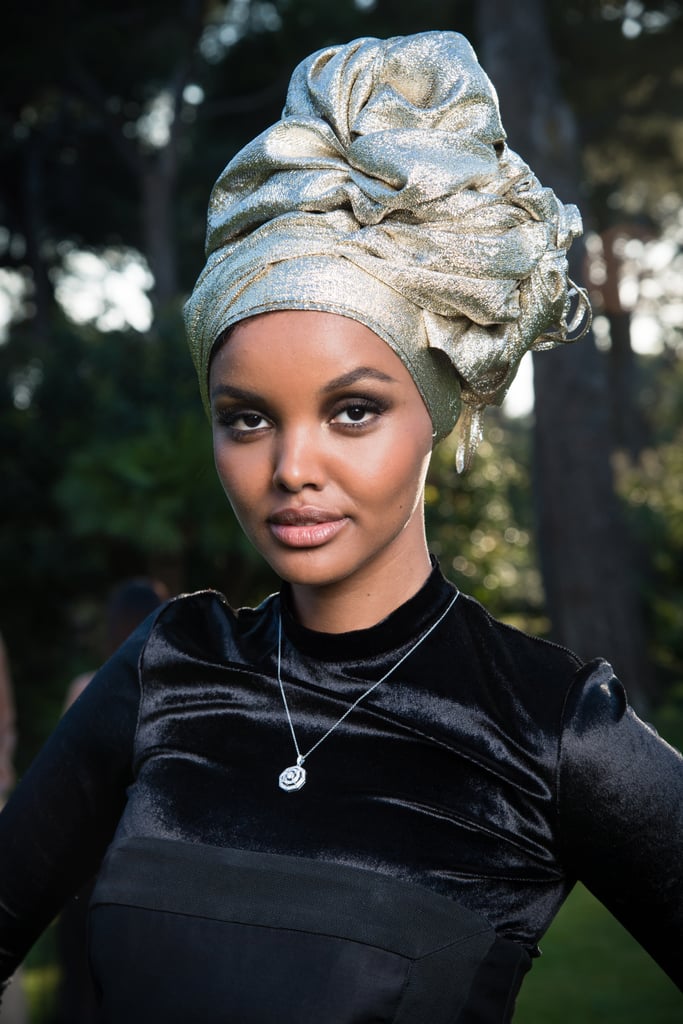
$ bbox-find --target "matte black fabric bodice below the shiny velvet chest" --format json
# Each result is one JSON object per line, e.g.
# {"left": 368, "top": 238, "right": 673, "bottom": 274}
{"left": 91, "top": 840, "right": 520, "bottom": 1024}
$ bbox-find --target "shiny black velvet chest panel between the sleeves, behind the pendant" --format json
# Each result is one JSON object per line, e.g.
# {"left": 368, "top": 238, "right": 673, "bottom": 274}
{"left": 113, "top": 569, "right": 579, "bottom": 949}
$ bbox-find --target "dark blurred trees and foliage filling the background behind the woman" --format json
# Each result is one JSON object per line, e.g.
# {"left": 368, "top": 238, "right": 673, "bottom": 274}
{"left": 0, "top": 0, "right": 683, "bottom": 768}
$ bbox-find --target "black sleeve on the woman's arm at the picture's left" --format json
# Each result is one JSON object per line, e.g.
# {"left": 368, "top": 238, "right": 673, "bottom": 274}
{"left": 0, "top": 620, "right": 151, "bottom": 988}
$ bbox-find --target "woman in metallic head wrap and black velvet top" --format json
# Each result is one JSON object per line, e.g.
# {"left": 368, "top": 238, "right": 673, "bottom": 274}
{"left": 0, "top": 33, "right": 683, "bottom": 1024}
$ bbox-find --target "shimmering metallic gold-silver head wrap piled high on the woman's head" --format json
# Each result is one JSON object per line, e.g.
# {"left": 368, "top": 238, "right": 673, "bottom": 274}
{"left": 185, "top": 32, "right": 589, "bottom": 469}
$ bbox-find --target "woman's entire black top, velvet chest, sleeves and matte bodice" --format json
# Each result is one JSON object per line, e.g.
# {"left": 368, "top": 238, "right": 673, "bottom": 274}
{"left": 0, "top": 568, "right": 683, "bottom": 1024}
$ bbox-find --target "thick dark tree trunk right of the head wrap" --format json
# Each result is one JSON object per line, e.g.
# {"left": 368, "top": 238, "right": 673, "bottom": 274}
{"left": 476, "top": 0, "right": 650, "bottom": 707}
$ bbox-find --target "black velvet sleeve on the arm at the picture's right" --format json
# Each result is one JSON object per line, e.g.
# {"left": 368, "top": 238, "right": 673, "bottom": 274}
{"left": 558, "top": 660, "right": 683, "bottom": 988}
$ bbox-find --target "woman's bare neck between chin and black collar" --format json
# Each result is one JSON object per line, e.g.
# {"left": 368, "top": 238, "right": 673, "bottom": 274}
{"left": 291, "top": 545, "right": 432, "bottom": 633}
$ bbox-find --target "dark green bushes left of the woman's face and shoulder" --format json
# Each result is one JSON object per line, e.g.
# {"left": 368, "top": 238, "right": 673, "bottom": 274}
{"left": 0, "top": 309, "right": 273, "bottom": 767}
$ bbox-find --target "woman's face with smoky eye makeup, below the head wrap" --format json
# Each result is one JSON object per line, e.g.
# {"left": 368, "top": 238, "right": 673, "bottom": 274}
{"left": 209, "top": 310, "right": 432, "bottom": 589}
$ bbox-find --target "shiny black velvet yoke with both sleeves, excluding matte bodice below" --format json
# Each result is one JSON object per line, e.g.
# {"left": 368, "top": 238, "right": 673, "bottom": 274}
{"left": 0, "top": 568, "right": 683, "bottom": 999}
